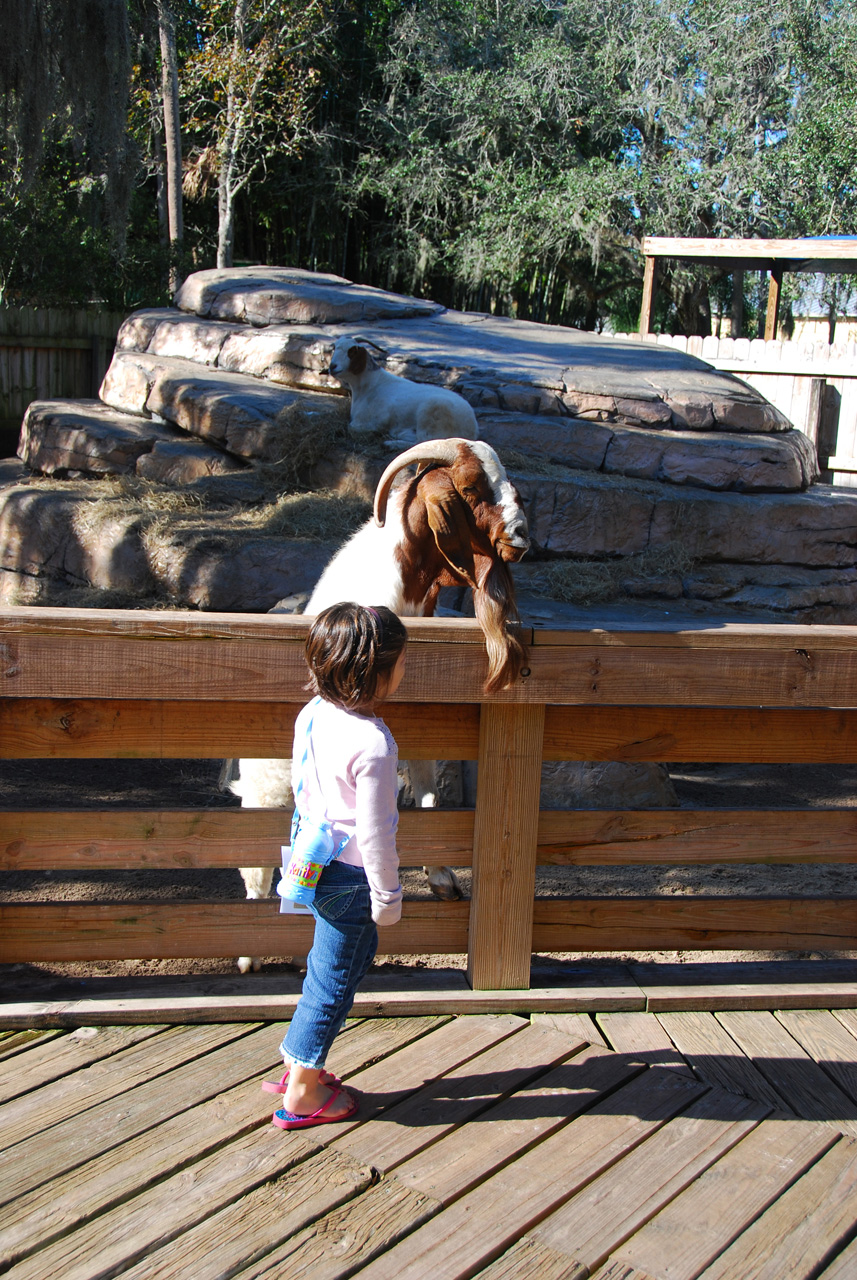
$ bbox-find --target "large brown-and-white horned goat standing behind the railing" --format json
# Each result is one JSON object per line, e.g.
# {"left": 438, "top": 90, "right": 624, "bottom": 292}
{"left": 232, "top": 439, "right": 530, "bottom": 973}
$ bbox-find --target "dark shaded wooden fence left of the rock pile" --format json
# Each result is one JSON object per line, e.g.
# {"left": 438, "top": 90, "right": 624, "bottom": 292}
{"left": 0, "top": 307, "right": 125, "bottom": 436}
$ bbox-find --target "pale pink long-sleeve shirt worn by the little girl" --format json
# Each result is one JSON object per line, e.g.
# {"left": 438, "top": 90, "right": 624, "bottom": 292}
{"left": 292, "top": 699, "right": 402, "bottom": 925}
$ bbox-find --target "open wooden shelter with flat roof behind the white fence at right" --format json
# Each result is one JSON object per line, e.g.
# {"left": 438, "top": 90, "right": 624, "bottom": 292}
{"left": 640, "top": 236, "right": 857, "bottom": 342}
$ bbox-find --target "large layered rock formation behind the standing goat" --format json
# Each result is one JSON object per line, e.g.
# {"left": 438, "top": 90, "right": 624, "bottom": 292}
{"left": 0, "top": 268, "right": 857, "bottom": 622}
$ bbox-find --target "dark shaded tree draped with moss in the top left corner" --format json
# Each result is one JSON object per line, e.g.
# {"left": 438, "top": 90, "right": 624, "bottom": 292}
{"left": 0, "top": 0, "right": 133, "bottom": 301}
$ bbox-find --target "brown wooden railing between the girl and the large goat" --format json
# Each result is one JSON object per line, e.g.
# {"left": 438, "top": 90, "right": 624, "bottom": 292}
{"left": 0, "top": 608, "right": 857, "bottom": 989}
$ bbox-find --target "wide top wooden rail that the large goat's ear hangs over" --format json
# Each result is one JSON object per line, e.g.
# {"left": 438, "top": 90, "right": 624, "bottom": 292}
{"left": 0, "top": 609, "right": 857, "bottom": 708}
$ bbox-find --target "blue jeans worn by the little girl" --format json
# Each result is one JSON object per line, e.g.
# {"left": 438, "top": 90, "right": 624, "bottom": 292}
{"left": 280, "top": 861, "right": 377, "bottom": 1068}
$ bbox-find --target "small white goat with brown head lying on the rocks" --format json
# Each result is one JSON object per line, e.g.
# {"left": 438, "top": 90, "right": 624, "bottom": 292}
{"left": 327, "top": 338, "right": 478, "bottom": 445}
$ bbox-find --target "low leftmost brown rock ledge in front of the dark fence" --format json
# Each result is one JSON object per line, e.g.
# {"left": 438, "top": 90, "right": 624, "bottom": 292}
{"left": 18, "top": 399, "right": 244, "bottom": 483}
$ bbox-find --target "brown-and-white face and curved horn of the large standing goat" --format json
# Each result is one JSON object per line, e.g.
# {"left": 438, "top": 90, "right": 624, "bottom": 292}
{"left": 375, "top": 438, "right": 530, "bottom": 579}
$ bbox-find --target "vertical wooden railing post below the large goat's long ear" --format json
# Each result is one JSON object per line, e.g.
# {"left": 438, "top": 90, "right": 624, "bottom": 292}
{"left": 467, "top": 703, "right": 545, "bottom": 991}
